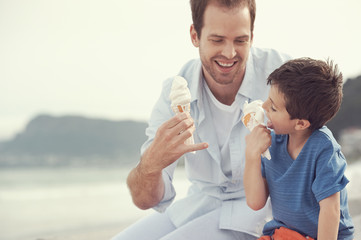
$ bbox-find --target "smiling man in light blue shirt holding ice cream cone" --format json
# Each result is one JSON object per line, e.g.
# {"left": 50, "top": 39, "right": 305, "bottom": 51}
{"left": 113, "top": 0, "right": 288, "bottom": 240}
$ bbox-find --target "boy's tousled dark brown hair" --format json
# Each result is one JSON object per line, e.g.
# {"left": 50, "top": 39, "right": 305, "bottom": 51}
{"left": 267, "top": 58, "right": 343, "bottom": 131}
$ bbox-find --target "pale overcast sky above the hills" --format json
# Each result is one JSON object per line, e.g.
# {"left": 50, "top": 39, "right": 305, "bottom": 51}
{"left": 0, "top": 0, "right": 361, "bottom": 140}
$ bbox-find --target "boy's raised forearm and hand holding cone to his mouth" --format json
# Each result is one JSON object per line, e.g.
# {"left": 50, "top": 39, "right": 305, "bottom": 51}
{"left": 243, "top": 125, "right": 271, "bottom": 210}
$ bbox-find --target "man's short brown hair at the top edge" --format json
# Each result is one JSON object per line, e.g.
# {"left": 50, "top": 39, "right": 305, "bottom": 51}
{"left": 190, "top": 0, "right": 256, "bottom": 38}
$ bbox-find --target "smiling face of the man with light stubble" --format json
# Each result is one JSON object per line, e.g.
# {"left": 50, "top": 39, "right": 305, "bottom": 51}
{"left": 191, "top": 3, "right": 252, "bottom": 85}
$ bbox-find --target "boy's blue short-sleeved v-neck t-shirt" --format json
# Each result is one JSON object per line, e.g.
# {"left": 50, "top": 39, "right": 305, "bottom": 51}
{"left": 262, "top": 127, "right": 354, "bottom": 239}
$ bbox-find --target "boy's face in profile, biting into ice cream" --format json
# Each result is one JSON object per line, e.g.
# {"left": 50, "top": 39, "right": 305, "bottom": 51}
{"left": 262, "top": 85, "right": 297, "bottom": 134}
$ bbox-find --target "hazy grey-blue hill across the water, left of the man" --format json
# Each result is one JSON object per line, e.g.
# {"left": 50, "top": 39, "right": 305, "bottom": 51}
{"left": 0, "top": 115, "right": 147, "bottom": 166}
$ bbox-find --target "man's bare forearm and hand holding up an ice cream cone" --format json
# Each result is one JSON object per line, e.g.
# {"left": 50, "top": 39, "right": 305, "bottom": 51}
{"left": 127, "top": 113, "right": 208, "bottom": 209}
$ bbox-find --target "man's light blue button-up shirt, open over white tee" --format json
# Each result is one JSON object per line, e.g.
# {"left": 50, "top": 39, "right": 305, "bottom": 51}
{"left": 141, "top": 47, "right": 290, "bottom": 236}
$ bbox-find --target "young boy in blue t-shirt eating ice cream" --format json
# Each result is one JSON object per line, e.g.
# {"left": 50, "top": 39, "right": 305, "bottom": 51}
{"left": 244, "top": 58, "right": 354, "bottom": 240}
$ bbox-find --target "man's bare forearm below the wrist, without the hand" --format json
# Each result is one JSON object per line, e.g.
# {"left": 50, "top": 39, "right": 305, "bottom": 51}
{"left": 127, "top": 162, "right": 164, "bottom": 210}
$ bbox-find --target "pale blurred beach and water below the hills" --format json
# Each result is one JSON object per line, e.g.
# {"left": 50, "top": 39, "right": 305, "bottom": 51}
{"left": 0, "top": 163, "right": 361, "bottom": 240}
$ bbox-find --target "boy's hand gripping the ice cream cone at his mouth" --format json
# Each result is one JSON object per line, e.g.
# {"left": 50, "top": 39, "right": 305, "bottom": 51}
{"left": 246, "top": 125, "right": 272, "bottom": 157}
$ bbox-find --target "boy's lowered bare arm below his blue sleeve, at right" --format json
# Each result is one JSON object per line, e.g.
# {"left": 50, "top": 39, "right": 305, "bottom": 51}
{"left": 317, "top": 192, "right": 340, "bottom": 240}
